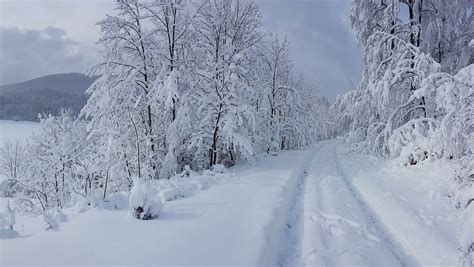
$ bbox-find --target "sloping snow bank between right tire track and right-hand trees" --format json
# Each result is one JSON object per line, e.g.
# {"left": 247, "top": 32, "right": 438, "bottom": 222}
{"left": 340, "top": 146, "right": 460, "bottom": 266}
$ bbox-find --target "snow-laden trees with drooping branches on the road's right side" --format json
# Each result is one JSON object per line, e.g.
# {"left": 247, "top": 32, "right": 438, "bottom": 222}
{"left": 342, "top": 0, "right": 474, "bottom": 263}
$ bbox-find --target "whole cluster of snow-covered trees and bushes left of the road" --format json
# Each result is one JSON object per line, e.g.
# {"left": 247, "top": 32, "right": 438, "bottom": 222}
{"left": 0, "top": 0, "right": 333, "bottom": 224}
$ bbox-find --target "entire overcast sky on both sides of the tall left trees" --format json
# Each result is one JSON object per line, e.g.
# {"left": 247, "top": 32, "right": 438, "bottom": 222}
{"left": 0, "top": 0, "right": 362, "bottom": 101}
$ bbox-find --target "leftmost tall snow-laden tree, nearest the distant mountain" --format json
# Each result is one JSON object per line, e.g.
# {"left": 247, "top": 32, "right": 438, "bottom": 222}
{"left": 82, "top": 0, "right": 158, "bottom": 182}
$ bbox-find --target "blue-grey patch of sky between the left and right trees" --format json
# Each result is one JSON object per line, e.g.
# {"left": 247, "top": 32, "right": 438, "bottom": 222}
{"left": 261, "top": 0, "right": 362, "bottom": 100}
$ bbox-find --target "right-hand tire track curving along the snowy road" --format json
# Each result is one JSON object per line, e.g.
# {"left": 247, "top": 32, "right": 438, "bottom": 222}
{"left": 333, "top": 141, "right": 419, "bottom": 266}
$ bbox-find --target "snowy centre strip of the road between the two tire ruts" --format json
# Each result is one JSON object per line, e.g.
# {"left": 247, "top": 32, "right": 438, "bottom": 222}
{"left": 298, "top": 141, "right": 409, "bottom": 266}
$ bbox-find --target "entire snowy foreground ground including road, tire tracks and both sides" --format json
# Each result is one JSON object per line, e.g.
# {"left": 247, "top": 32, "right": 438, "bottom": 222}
{"left": 0, "top": 140, "right": 459, "bottom": 266}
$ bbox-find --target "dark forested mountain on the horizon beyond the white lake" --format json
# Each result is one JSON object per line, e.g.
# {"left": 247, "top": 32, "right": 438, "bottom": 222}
{"left": 0, "top": 73, "right": 97, "bottom": 121}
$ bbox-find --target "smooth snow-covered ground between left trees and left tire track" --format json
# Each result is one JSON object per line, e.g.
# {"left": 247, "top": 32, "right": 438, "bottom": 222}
{"left": 0, "top": 151, "right": 314, "bottom": 266}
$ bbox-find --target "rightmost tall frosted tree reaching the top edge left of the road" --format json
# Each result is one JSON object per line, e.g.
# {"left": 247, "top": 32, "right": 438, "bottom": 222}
{"left": 189, "top": 0, "right": 262, "bottom": 166}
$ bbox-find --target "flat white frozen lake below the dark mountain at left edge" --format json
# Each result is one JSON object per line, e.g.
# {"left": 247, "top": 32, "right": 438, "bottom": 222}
{"left": 0, "top": 120, "right": 39, "bottom": 146}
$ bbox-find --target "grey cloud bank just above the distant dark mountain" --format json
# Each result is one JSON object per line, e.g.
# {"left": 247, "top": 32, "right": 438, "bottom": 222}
{"left": 0, "top": 27, "right": 90, "bottom": 84}
